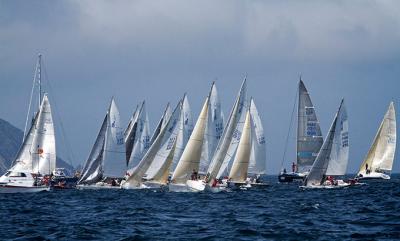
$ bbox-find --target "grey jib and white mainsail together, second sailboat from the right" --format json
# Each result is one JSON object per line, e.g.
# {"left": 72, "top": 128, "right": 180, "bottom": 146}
{"left": 305, "top": 100, "right": 349, "bottom": 186}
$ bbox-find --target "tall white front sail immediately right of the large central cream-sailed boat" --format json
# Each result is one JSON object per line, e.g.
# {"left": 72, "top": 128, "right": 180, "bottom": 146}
{"left": 207, "top": 79, "right": 246, "bottom": 182}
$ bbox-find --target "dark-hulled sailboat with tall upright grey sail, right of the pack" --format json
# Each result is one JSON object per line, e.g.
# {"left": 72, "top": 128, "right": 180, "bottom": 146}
{"left": 278, "top": 79, "right": 323, "bottom": 182}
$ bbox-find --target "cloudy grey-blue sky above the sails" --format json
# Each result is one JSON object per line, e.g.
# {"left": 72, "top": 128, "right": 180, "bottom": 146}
{"left": 0, "top": 0, "right": 400, "bottom": 174}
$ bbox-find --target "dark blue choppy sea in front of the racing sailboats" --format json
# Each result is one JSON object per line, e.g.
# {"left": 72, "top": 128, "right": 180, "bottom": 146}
{"left": 0, "top": 175, "right": 400, "bottom": 240}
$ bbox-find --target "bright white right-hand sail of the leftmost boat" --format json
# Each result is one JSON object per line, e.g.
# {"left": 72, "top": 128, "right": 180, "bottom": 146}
{"left": 31, "top": 94, "right": 56, "bottom": 175}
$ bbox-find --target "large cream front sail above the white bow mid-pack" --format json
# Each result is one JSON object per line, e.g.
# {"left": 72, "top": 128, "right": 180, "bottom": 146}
{"left": 171, "top": 97, "right": 209, "bottom": 184}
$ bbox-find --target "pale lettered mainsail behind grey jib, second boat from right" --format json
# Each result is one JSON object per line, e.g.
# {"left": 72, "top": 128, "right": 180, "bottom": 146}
{"left": 326, "top": 102, "right": 349, "bottom": 176}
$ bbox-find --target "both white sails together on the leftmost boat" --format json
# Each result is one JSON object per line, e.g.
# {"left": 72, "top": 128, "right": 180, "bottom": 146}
{"left": 11, "top": 94, "right": 56, "bottom": 175}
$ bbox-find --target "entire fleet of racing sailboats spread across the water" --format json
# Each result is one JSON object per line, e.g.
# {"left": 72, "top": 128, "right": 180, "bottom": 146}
{"left": 0, "top": 55, "right": 396, "bottom": 193}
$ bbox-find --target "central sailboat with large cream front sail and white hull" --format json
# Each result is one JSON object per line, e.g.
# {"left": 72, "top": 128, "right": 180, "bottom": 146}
{"left": 168, "top": 86, "right": 210, "bottom": 192}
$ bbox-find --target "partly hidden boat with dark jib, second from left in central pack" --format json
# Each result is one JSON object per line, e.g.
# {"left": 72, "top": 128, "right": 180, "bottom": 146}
{"left": 124, "top": 101, "right": 150, "bottom": 169}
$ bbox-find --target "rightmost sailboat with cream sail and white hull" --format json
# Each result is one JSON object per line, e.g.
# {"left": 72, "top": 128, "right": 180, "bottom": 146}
{"left": 357, "top": 102, "right": 396, "bottom": 180}
